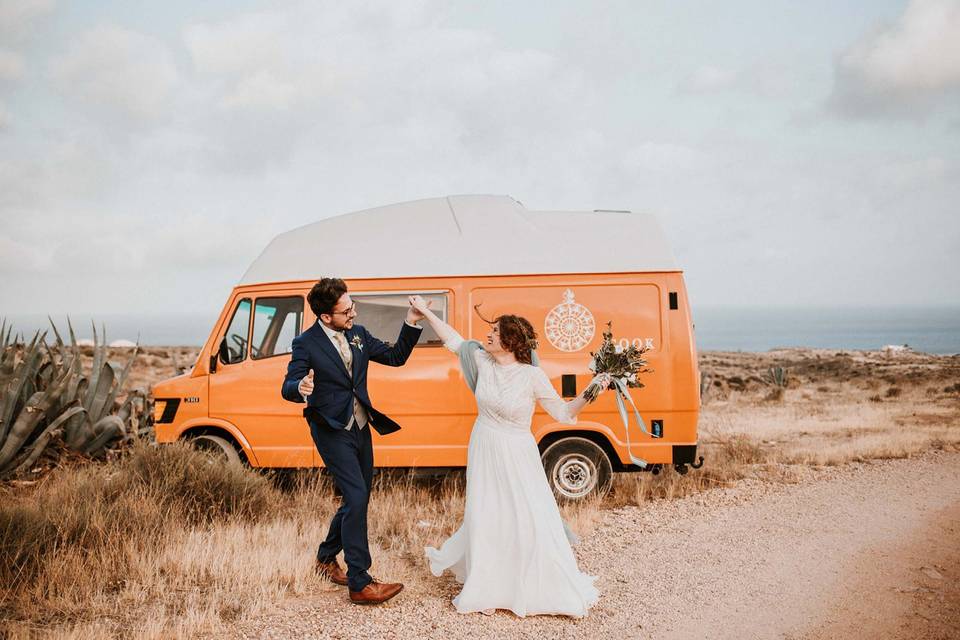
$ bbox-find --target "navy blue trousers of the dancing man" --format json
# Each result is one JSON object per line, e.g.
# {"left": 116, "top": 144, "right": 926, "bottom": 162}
{"left": 308, "top": 420, "right": 373, "bottom": 591}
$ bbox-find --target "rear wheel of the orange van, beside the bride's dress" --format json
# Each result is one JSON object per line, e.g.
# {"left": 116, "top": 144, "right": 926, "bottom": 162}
{"left": 540, "top": 438, "right": 613, "bottom": 501}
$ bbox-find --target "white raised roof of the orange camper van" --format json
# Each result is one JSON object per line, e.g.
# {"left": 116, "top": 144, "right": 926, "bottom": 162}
{"left": 240, "top": 195, "right": 680, "bottom": 284}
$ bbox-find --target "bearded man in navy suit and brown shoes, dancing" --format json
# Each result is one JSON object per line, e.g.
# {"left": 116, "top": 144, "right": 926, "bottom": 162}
{"left": 281, "top": 278, "right": 423, "bottom": 604}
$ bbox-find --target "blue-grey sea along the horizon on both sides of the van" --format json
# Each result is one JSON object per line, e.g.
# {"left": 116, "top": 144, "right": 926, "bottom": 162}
{"left": 0, "top": 305, "right": 960, "bottom": 354}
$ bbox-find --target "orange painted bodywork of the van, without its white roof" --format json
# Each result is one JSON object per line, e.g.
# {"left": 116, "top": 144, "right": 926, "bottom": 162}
{"left": 155, "top": 271, "right": 700, "bottom": 467}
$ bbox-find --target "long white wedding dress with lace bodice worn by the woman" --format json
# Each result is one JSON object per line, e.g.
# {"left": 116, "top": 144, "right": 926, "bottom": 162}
{"left": 424, "top": 338, "right": 599, "bottom": 617}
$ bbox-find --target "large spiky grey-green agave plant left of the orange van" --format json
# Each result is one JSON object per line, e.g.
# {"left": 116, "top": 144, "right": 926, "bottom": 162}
{"left": 0, "top": 320, "right": 149, "bottom": 477}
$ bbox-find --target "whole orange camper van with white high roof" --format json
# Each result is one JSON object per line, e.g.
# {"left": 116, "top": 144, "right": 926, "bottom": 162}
{"left": 153, "top": 196, "right": 703, "bottom": 499}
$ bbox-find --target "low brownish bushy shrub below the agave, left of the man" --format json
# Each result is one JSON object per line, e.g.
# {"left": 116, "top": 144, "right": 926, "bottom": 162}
{"left": 0, "top": 444, "right": 278, "bottom": 600}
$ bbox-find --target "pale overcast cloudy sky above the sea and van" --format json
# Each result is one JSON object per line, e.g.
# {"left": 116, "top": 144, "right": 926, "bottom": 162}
{"left": 0, "top": 0, "right": 960, "bottom": 315}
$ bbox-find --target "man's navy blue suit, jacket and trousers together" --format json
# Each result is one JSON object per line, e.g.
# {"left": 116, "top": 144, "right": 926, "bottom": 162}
{"left": 281, "top": 323, "right": 421, "bottom": 591}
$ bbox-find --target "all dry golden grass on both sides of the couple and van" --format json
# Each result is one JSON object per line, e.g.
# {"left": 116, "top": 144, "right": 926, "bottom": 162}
{"left": 0, "top": 352, "right": 960, "bottom": 638}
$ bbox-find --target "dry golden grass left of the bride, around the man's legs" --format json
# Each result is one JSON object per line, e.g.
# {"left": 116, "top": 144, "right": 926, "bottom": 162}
{"left": 0, "top": 446, "right": 463, "bottom": 638}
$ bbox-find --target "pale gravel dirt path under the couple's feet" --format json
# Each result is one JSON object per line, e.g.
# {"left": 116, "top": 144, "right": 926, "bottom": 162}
{"left": 236, "top": 453, "right": 960, "bottom": 640}
